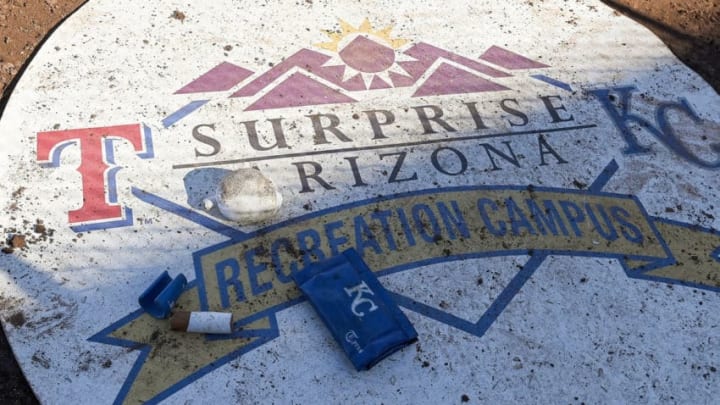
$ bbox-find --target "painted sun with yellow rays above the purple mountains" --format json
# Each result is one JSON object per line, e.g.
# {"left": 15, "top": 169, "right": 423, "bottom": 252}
{"left": 315, "top": 18, "right": 414, "bottom": 87}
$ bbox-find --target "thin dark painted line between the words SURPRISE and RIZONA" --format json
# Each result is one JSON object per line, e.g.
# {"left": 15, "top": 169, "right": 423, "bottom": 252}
{"left": 173, "top": 124, "right": 597, "bottom": 169}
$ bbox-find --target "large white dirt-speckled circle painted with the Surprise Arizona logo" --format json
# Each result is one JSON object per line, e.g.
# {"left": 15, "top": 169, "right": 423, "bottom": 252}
{"left": 0, "top": 0, "right": 720, "bottom": 403}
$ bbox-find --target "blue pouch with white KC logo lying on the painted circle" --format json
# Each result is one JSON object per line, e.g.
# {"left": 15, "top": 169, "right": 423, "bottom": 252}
{"left": 292, "top": 249, "right": 417, "bottom": 371}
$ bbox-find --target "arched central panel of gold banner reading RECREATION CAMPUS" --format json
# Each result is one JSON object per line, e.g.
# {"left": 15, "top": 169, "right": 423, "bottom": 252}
{"left": 197, "top": 188, "right": 670, "bottom": 319}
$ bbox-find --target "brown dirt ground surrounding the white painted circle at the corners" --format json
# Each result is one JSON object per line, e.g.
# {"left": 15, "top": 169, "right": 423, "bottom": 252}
{"left": 0, "top": 0, "right": 720, "bottom": 404}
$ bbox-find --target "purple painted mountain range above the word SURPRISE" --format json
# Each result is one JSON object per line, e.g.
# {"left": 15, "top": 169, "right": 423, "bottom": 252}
{"left": 176, "top": 35, "right": 548, "bottom": 110}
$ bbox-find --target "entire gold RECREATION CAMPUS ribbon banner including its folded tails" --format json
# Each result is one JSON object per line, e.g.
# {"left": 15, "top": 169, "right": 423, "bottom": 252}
{"left": 98, "top": 187, "right": 720, "bottom": 403}
